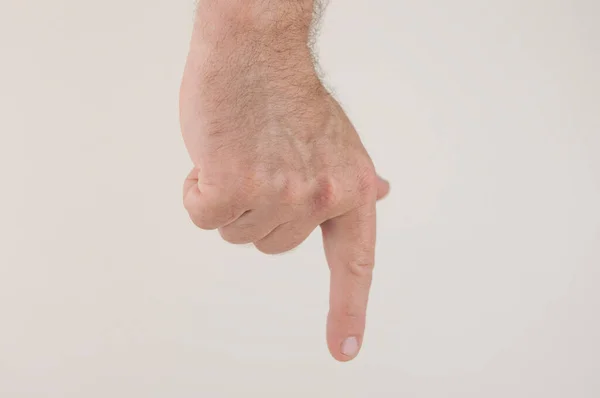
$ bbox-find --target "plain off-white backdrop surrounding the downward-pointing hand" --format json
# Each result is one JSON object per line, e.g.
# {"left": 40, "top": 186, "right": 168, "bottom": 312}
{"left": 0, "top": 0, "right": 600, "bottom": 398}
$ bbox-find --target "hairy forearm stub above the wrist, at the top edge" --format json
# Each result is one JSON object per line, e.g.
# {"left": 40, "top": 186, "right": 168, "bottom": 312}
{"left": 187, "top": 0, "right": 322, "bottom": 95}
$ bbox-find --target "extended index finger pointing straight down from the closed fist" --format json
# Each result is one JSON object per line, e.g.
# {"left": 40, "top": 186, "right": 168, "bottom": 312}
{"left": 321, "top": 201, "right": 375, "bottom": 362}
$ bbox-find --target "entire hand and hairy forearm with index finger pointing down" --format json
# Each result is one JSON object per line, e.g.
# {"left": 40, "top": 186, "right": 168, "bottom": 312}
{"left": 180, "top": 0, "right": 389, "bottom": 361}
